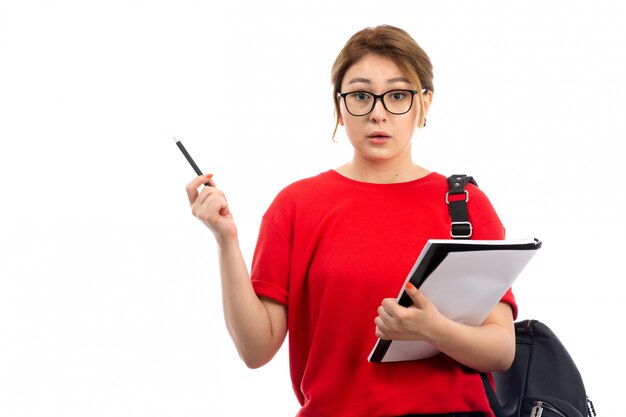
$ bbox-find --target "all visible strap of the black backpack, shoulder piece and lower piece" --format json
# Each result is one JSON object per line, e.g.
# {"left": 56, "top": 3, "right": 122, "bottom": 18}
{"left": 446, "top": 175, "right": 506, "bottom": 417}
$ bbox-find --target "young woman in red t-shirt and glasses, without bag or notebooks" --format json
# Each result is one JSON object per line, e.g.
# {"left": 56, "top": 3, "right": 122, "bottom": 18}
{"left": 187, "top": 26, "right": 517, "bottom": 417}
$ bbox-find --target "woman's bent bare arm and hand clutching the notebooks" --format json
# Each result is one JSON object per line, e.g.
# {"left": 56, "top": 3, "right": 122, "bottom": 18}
{"left": 375, "top": 285, "right": 515, "bottom": 372}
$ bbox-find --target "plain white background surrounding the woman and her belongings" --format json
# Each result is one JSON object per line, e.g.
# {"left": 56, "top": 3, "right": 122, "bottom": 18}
{"left": 0, "top": 0, "right": 626, "bottom": 417}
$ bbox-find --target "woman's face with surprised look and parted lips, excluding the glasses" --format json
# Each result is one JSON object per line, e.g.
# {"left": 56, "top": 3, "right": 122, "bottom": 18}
{"left": 339, "top": 55, "right": 430, "bottom": 162}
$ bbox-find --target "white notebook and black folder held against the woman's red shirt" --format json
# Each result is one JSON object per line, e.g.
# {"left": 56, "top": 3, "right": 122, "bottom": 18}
{"left": 368, "top": 239, "right": 541, "bottom": 362}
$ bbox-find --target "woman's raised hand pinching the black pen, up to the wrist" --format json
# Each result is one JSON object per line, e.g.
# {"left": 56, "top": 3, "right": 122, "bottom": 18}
{"left": 186, "top": 174, "right": 237, "bottom": 242}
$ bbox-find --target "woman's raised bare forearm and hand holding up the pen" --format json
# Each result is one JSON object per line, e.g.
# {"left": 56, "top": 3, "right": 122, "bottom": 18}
{"left": 187, "top": 176, "right": 287, "bottom": 368}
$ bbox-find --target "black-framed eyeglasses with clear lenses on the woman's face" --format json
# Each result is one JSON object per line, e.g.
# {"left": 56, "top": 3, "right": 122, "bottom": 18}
{"left": 337, "top": 89, "right": 426, "bottom": 116}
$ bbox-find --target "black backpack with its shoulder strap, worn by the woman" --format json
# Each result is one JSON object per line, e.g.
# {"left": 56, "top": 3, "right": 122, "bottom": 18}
{"left": 446, "top": 175, "right": 596, "bottom": 417}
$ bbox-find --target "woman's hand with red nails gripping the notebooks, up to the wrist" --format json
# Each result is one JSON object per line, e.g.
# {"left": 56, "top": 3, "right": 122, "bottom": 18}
{"left": 374, "top": 283, "right": 443, "bottom": 341}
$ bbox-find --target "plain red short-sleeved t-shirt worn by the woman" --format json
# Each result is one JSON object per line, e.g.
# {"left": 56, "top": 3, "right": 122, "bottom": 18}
{"left": 251, "top": 171, "right": 517, "bottom": 417}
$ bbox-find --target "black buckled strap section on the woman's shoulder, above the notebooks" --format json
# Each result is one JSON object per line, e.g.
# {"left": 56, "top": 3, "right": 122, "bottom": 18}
{"left": 446, "top": 175, "right": 478, "bottom": 239}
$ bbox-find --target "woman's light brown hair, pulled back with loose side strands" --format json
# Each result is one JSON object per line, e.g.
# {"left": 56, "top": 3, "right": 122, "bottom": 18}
{"left": 331, "top": 25, "right": 434, "bottom": 137}
